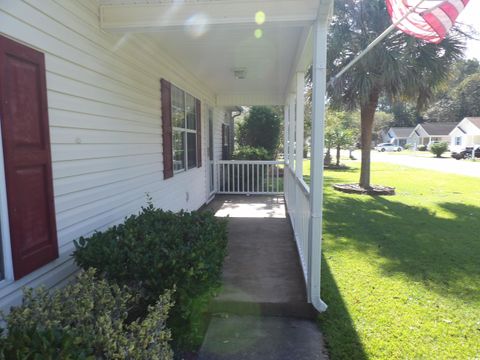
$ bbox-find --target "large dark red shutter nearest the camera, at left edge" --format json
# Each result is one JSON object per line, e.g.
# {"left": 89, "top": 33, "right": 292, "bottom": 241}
{"left": 0, "top": 36, "right": 58, "bottom": 279}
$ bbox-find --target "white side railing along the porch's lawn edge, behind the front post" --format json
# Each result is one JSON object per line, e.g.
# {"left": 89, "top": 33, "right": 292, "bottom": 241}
{"left": 284, "top": 166, "right": 310, "bottom": 288}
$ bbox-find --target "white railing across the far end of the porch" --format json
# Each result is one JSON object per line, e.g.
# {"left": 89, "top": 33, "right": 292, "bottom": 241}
{"left": 215, "top": 160, "right": 284, "bottom": 195}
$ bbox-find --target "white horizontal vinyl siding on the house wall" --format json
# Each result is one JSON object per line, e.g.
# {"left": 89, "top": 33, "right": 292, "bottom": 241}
{"left": 0, "top": 0, "right": 228, "bottom": 309}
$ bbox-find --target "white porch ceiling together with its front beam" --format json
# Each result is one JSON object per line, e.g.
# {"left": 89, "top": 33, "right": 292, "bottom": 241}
{"left": 95, "top": 0, "right": 333, "bottom": 106}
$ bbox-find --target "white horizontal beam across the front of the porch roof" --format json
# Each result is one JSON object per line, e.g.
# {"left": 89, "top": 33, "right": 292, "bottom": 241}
{"left": 100, "top": 0, "right": 323, "bottom": 32}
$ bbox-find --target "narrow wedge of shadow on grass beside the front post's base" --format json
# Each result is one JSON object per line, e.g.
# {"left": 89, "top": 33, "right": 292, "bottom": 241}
{"left": 319, "top": 256, "right": 367, "bottom": 360}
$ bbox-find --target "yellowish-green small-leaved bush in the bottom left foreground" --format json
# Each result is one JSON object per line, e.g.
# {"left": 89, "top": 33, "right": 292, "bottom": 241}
{"left": 0, "top": 269, "right": 173, "bottom": 360}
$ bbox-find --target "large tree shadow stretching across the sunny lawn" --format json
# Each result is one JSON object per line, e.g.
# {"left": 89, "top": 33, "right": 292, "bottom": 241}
{"left": 324, "top": 196, "right": 480, "bottom": 301}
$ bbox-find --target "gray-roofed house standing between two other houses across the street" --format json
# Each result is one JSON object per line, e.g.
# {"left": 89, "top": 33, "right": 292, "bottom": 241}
{"left": 407, "top": 122, "right": 458, "bottom": 148}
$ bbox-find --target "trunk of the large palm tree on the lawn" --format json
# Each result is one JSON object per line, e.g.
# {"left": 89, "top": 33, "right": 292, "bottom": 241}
{"left": 360, "top": 89, "right": 380, "bottom": 189}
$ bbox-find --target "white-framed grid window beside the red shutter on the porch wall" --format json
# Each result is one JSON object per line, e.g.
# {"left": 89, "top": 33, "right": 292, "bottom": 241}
{"left": 172, "top": 85, "right": 197, "bottom": 173}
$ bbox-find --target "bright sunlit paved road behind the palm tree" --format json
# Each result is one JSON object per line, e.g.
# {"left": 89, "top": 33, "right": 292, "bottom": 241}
{"left": 368, "top": 151, "right": 480, "bottom": 178}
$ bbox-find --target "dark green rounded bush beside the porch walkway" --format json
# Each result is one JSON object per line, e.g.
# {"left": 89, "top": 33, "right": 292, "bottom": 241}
{"left": 74, "top": 204, "right": 227, "bottom": 348}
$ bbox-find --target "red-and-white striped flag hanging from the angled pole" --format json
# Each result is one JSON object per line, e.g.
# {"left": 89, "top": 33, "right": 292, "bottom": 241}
{"left": 386, "top": 0, "right": 470, "bottom": 44}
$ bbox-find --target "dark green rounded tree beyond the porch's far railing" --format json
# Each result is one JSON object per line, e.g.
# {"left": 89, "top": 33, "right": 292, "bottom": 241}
{"left": 238, "top": 106, "right": 281, "bottom": 154}
